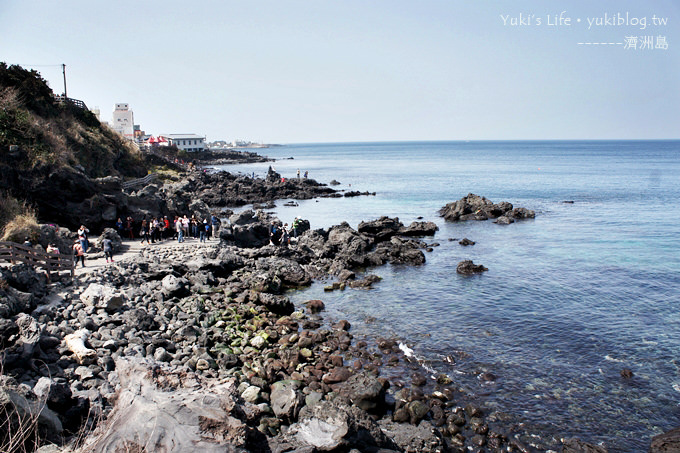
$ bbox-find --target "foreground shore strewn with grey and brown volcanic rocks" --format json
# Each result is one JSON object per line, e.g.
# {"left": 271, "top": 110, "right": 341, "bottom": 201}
{"left": 0, "top": 172, "right": 676, "bottom": 453}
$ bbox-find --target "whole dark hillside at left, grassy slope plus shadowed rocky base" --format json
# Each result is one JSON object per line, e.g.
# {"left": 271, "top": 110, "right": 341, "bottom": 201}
{"left": 0, "top": 63, "right": 148, "bottom": 236}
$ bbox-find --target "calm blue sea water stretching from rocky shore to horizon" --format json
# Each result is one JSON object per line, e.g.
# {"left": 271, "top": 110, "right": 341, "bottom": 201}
{"left": 218, "top": 141, "right": 680, "bottom": 452}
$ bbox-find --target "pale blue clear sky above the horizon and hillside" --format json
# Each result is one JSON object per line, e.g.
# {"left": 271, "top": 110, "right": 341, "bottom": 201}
{"left": 0, "top": 0, "right": 680, "bottom": 143}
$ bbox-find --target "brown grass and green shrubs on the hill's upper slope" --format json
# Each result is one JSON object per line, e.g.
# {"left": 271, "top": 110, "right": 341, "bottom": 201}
{"left": 0, "top": 63, "right": 146, "bottom": 178}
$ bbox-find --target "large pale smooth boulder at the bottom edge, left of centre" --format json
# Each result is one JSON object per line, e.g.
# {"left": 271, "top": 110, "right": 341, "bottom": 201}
{"left": 83, "top": 359, "right": 247, "bottom": 453}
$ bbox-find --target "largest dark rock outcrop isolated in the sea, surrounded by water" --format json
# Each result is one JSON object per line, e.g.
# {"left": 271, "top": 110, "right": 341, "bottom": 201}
{"left": 439, "top": 193, "right": 536, "bottom": 224}
